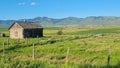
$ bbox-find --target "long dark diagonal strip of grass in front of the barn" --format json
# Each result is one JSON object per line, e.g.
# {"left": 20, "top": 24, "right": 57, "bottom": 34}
{"left": 0, "top": 35, "right": 93, "bottom": 52}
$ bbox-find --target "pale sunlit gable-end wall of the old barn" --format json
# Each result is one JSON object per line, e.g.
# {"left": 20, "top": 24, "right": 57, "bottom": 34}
{"left": 9, "top": 23, "right": 24, "bottom": 39}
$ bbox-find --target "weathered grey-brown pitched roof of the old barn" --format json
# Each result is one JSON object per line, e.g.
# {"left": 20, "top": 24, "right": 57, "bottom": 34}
{"left": 9, "top": 21, "right": 42, "bottom": 29}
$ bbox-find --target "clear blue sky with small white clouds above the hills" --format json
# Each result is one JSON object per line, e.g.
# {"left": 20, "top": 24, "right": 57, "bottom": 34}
{"left": 0, "top": 0, "right": 120, "bottom": 20}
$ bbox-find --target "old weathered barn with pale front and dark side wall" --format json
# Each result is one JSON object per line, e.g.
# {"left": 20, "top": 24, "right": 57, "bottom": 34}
{"left": 8, "top": 21, "right": 43, "bottom": 39}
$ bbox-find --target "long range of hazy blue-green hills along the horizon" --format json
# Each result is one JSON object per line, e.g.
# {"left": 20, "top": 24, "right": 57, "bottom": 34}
{"left": 0, "top": 16, "right": 120, "bottom": 27}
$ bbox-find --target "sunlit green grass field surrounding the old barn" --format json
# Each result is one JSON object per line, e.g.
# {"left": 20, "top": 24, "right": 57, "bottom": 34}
{"left": 0, "top": 26, "right": 120, "bottom": 68}
